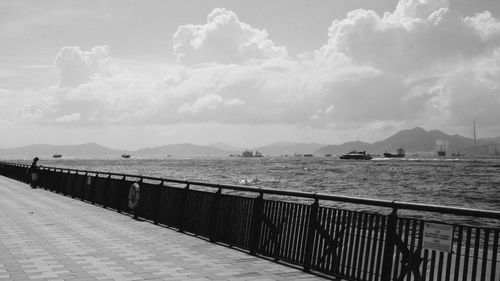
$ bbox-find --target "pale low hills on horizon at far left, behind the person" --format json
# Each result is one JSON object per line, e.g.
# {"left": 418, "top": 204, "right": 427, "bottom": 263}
{"left": 0, "top": 143, "right": 130, "bottom": 158}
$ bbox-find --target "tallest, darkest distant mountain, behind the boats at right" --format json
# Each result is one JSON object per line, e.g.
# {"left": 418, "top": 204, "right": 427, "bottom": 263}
{"left": 316, "top": 127, "right": 491, "bottom": 155}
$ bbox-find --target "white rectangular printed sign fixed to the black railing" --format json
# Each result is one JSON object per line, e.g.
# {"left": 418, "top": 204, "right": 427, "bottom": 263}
{"left": 423, "top": 222, "right": 453, "bottom": 252}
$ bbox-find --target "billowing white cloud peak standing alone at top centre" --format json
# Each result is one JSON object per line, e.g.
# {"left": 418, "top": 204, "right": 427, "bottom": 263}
{"left": 173, "top": 9, "right": 287, "bottom": 63}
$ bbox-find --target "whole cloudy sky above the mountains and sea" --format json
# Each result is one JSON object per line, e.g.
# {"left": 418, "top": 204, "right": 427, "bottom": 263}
{"left": 0, "top": 0, "right": 500, "bottom": 149}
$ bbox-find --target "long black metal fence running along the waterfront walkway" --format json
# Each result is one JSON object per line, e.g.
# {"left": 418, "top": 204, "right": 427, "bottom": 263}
{"left": 0, "top": 162, "right": 500, "bottom": 281}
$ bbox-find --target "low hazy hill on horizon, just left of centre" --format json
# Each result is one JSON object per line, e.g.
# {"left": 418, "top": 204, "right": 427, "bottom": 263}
{"left": 134, "top": 143, "right": 231, "bottom": 158}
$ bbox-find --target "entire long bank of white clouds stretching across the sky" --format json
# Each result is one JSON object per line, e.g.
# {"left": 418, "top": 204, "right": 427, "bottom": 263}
{"left": 3, "top": 0, "right": 500, "bottom": 141}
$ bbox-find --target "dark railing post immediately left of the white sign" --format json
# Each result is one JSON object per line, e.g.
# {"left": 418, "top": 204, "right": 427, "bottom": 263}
{"left": 381, "top": 207, "right": 398, "bottom": 281}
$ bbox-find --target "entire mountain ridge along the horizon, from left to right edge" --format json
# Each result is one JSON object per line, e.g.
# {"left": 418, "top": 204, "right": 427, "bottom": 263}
{"left": 0, "top": 127, "right": 500, "bottom": 158}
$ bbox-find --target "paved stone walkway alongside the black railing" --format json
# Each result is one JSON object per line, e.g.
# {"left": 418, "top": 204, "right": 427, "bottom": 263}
{"left": 0, "top": 176, "right": 332, "bottom": 281}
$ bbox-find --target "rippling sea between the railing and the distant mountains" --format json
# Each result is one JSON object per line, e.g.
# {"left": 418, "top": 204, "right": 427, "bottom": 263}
{"left": 18, "top": 157, "right": 500, "bottom": 226}
